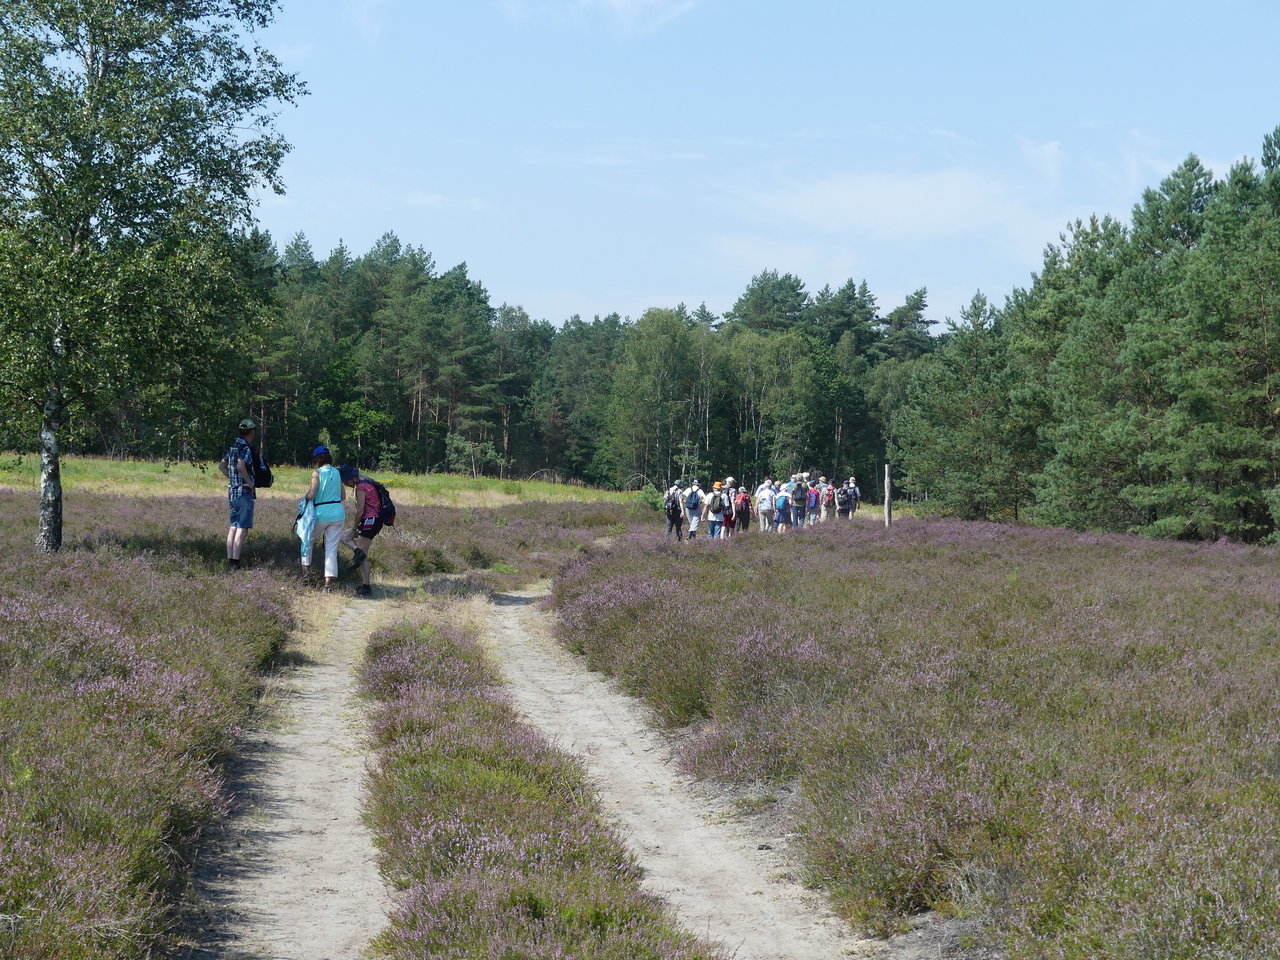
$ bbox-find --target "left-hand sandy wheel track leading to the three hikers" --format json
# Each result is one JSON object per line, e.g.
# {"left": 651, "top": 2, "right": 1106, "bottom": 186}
{"left": 187, "top": 600, "right": 389, "bottom": 960}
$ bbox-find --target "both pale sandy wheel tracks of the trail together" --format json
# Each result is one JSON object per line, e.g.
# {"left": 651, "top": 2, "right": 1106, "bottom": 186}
{"left": 183, "top": 578, "right": 952, "bottom": 960}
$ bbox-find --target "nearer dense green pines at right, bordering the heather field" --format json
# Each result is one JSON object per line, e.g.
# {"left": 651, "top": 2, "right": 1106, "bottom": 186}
{"left": 887, "top": 128, "right": 1280, "bottom": 543}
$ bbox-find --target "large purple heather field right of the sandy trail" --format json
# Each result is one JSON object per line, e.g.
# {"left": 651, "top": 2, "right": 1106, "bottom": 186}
{"left": 556, "top": 521, "right": 1280, "bottom": 960}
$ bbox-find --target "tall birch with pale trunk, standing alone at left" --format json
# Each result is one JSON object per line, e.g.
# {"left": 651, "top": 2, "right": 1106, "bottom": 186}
{"left": 0, "top": 0, "right": 301, "bottom": 549}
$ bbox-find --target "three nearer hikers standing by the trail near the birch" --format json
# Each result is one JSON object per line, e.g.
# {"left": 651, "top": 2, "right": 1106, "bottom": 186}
{"left": 218, "top": 417, "right": 394, "bottom": 596}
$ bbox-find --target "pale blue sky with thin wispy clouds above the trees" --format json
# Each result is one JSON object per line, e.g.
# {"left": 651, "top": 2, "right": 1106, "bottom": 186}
{"left": 249, "top": 0, "right": 1280, "bottom": 323}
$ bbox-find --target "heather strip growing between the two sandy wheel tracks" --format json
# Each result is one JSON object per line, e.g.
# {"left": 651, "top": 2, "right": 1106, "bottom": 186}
{"left": 361, "top": 616, "right": 719, "bottom": 960}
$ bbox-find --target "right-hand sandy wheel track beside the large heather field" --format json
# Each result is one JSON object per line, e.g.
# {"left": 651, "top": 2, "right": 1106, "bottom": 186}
{"left": 488, "top": 591, "right": 874, "bottom": 960}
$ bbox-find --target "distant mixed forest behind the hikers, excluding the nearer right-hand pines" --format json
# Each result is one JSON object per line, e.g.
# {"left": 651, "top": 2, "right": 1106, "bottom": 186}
{"left": 30, "top": 226, "right": 933, "bottom": 499}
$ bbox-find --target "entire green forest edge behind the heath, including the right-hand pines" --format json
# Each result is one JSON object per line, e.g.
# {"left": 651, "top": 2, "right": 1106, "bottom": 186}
{"left": 20, "top": 131, "right": 1280, "bottom": 541}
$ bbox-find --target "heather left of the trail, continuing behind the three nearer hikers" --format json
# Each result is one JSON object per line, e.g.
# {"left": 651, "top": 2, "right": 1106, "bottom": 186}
{"left": 0, "top": 474, "right": 654, "bottom": 960}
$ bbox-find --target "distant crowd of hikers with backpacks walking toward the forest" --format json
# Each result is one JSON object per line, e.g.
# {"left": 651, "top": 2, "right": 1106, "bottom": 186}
{"left": 663, "top": 472, "right": 863, "bottom": 540}
